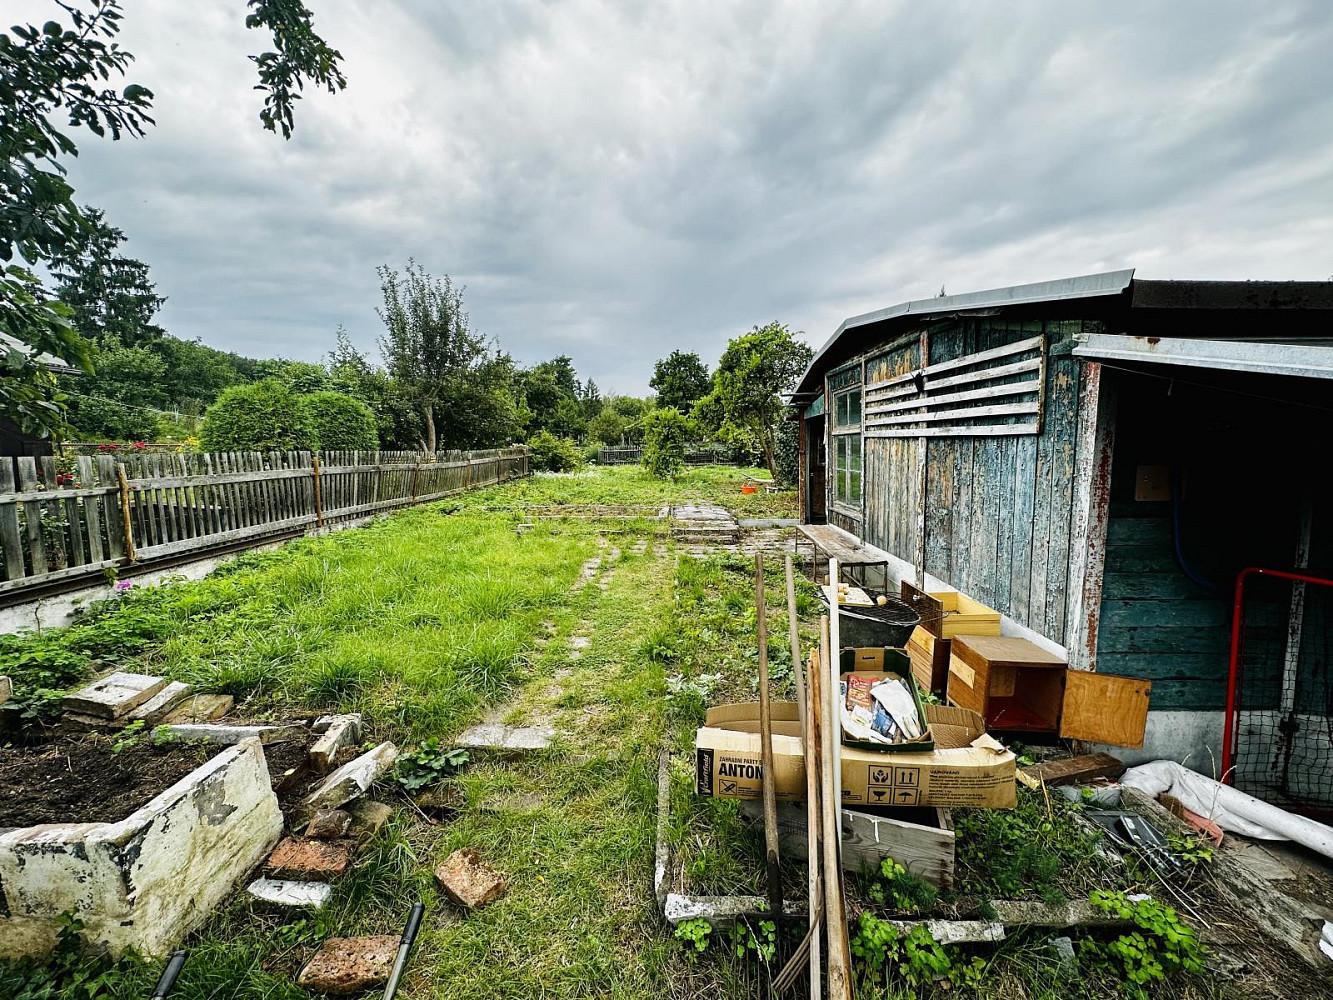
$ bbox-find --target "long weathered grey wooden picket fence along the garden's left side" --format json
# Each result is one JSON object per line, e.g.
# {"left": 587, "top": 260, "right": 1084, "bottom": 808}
{"left": 0, "top": 448, "right": 528, "bottom": 597}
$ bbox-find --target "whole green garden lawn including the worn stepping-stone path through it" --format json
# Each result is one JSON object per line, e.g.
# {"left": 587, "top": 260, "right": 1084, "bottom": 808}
{"left": 0, "top": 467, "right": 1231, "bottom": 1000}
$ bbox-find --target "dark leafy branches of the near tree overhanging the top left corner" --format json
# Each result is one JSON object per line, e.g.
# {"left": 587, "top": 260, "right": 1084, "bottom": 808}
{"left": 0, "top": 0, "right": 345, "bottom": 433}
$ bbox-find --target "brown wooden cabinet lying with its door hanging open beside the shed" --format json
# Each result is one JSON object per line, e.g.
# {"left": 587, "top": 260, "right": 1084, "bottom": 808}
{"left": 948, "top": 636, "right": 1152, "bottom": 747}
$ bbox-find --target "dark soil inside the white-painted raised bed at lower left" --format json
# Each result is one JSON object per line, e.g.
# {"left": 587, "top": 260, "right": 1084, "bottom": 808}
{"left": 0, "top": 736, "right": 221, "bottom": 829}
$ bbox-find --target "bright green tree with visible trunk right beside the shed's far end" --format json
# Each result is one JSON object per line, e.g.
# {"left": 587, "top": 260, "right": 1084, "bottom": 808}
{"left": 694, "top": 323, "right": 814, "bottom": 479}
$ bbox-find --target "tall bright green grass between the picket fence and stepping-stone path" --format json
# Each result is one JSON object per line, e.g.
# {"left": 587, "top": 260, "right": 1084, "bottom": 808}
{"left": 0, "top": 507, "right": 595, "bottom": 739}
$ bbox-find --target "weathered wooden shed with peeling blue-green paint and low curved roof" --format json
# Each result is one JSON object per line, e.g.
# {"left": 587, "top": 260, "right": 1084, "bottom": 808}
{"left": 790, "top": 271, "right": 1333, "bottom": 803}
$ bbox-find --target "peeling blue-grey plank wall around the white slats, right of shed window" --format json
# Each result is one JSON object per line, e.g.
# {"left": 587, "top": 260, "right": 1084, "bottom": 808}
{"left": 849, "top": 316, "right": 1082, "bottom": 643}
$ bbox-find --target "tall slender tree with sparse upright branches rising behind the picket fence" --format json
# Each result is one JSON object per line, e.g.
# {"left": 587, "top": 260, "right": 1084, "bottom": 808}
{"left": 376, "top": 260, "right": 485, "bottom": 452}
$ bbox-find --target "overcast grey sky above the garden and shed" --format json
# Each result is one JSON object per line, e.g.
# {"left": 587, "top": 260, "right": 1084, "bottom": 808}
{"left": 20, "top": 0, "right": 1333, "bottom": 393}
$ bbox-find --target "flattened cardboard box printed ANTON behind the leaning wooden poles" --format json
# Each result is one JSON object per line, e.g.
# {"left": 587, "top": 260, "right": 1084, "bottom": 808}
{"left": 694, "top": 701, "right": 1016, "bottom": 809}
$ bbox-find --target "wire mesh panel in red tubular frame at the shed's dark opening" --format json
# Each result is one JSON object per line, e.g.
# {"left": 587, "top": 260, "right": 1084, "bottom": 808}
{"left": 1224, "top": 569, "right": 1333, "bottom": 813}
